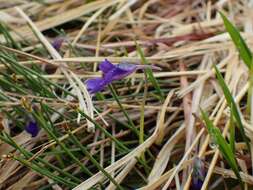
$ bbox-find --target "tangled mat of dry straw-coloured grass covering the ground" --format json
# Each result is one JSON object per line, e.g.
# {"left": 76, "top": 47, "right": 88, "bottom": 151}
{"left": 0, "top": 0, "right": 253, "bottom": 190}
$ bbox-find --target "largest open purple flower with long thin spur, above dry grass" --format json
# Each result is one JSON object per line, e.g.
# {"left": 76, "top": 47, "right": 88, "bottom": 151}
{"left": 86, "top": 59, "right": 160, "bottom": 94}
